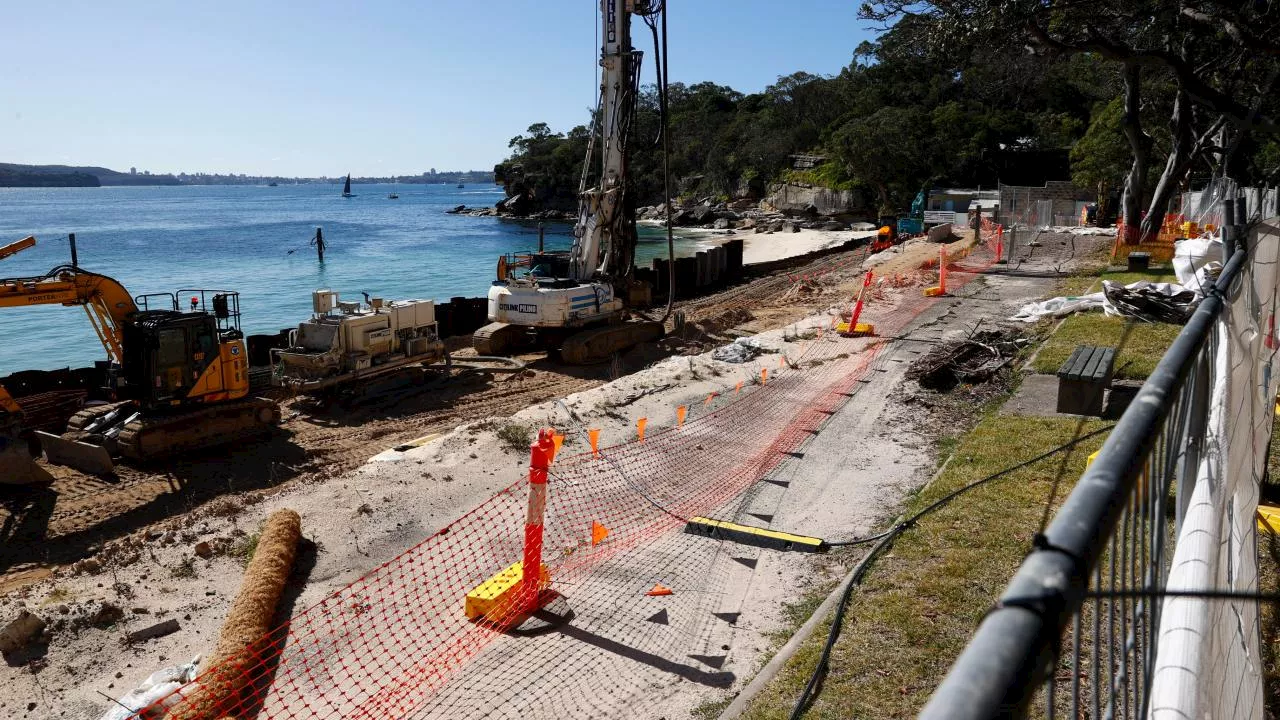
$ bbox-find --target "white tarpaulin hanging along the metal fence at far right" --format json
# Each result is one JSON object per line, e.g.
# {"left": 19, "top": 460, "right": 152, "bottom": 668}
{"left": 1149, "top": 218, "right": 1280, "bottom": 720}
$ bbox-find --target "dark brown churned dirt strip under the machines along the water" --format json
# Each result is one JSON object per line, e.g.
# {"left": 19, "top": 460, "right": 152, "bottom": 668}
{"left": 0, "top": 231, "right": 880, "bottom": 593}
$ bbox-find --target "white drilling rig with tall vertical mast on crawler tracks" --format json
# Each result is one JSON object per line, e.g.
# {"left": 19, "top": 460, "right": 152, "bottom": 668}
{"left": 472, "top": 0, "right": 663, "bottom": 364}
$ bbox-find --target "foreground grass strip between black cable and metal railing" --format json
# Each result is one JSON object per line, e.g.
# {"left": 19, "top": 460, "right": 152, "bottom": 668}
{"left": 746, "top": 415, "right": 1103, "bottom": 720}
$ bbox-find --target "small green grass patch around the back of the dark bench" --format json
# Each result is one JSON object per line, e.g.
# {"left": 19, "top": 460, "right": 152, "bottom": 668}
{"left": 1032, "top": 313, "right": 1183, "bottom": 379}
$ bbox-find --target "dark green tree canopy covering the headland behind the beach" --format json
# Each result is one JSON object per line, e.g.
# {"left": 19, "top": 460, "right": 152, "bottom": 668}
{"left": 499, "top": 0, "right": 1280, "bottom": 224}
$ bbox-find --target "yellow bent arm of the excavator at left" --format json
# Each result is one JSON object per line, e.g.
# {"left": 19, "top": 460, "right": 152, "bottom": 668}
{"left": 0, "top": 256, "right": 138, "bottom": 364}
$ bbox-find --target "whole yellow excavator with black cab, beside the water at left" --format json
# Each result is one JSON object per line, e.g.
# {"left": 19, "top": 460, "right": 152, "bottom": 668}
{"left": 0, "top": 236, "right": 280, "bottom": 483}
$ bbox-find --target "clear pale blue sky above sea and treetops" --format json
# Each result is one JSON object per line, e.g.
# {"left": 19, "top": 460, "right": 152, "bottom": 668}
{"left": 0, "top": 0, "right": 873, "bottom": 176}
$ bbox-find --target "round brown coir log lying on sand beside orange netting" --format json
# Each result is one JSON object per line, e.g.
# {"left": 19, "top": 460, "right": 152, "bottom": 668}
{"left": 166, "top": 510, "right": 302, "bottom": 720}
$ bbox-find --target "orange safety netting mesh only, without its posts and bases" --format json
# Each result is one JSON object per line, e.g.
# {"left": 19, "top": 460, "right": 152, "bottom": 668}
{"left": 145, "top": 228, "right": 995, "bottom": 719}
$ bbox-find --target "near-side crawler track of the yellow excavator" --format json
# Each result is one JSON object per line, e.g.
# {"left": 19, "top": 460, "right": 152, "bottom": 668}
{"left": 116, "top": 397, "right": 280, "bottom": 461}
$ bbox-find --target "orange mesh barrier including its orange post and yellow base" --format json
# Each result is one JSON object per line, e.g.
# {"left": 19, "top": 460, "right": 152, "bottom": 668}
{"left": 145, "top": 228, "right": 996, "bottom": 719}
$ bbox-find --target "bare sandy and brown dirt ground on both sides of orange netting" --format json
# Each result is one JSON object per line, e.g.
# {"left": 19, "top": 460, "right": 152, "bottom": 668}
{"left": 0, "top": 226, "right": 1105, "bottom": 717}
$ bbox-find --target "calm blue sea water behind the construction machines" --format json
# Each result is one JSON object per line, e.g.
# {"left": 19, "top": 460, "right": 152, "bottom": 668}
{"left": 0, "top": 184, "right": 721, "bottom": 375}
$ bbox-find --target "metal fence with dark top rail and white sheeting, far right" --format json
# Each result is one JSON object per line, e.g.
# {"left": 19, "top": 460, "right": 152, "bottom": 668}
{"left": 922, "top": 196, "right": 1280, "bottom": 719}
